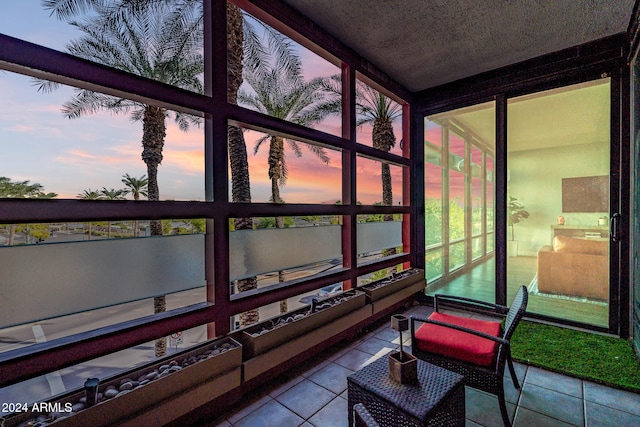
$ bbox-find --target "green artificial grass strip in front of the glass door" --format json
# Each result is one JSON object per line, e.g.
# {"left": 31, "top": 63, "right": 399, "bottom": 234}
{"left": 511, "top": 321, "right": 640, "bottom": 392}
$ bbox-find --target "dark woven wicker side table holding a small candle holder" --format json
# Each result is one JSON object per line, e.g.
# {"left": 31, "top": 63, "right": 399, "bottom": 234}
{"left": 347, "top": 357, "right": 465, "bottom": 427}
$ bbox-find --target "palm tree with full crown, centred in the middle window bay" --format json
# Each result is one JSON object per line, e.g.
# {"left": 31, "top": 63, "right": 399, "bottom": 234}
{"left": 238, "top": 53, "right": 332, "bottom": 313}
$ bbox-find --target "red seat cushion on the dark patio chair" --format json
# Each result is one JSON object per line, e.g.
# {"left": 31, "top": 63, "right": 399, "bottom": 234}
{"left": 415, "top": 312, "right": 501, "bottom": 366}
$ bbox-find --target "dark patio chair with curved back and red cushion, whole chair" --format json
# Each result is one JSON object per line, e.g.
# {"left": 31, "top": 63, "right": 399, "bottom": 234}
{"left": 411, "top": 286, "right": 528, "bottom": 426}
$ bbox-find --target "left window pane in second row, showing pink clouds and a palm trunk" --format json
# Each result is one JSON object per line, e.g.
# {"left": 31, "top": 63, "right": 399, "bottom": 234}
{"left": 0, "top": 72, "right": 204, "bottom": 200}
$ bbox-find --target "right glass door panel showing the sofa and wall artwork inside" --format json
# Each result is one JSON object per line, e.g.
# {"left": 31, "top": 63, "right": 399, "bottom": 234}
{"left": 507, "top": 78, "right": 611, "bottom": 327}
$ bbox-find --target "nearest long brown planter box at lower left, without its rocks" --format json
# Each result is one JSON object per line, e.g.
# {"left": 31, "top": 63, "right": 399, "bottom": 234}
{"left": 4, "top": 338, "right": 242, "bottom": 427}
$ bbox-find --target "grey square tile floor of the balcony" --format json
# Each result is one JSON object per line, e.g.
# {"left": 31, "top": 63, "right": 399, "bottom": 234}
{"left": 198, "top": 306, "right": 640, "bottom": 427}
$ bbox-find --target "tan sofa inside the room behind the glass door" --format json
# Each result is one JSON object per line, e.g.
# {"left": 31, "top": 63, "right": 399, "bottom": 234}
{"left": 538, "top": 236, "right": 609, "bottom": 301}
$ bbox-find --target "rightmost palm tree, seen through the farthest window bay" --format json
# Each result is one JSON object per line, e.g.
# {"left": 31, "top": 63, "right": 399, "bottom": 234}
{"left": 324, "top": 76, "right": 402, "bottom": 255}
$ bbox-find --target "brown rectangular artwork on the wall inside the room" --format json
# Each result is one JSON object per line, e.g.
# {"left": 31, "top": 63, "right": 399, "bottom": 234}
{"left": 562, "top": 175, "right": 609, "bottom": 212}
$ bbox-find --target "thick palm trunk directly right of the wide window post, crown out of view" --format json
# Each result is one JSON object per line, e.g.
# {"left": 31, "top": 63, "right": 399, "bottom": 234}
{"left": 227, "top": 2, "right": 260, "bottom": 326}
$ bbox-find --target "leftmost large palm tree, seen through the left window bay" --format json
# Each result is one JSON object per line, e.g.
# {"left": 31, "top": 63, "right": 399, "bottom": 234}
{"left": 40, "top": 0, "right": 204, "bottom": 356}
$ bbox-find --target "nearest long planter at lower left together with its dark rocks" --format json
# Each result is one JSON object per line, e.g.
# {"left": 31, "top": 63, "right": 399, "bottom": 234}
{"left": 3, "top": 337, "right": 242, "bottom": 427}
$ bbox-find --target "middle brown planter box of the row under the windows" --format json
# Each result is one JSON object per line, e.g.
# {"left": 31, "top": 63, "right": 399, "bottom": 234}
{"left": 232, "top": 290, "right": 366, "bottom": 360}
